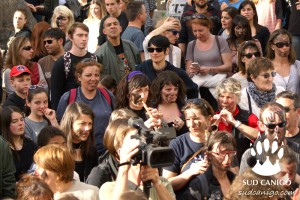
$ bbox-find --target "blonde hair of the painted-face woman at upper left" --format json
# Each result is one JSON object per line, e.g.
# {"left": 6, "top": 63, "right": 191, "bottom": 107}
{"left": 51, "top": 5, "right": 75, "bottom": 33}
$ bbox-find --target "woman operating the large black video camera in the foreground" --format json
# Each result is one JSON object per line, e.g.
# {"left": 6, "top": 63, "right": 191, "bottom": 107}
{"left": 99, "top": 120, "right": 175, "bottom": 200}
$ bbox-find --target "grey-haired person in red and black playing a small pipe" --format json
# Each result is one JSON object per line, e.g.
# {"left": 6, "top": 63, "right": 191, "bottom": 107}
{"left": 213, "top": 78, "right": 259, "bottom": 163}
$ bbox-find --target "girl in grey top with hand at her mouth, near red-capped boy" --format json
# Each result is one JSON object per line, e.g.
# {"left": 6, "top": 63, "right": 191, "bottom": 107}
{"left": 25, "top": 85, "right": 59, "bottom": 143}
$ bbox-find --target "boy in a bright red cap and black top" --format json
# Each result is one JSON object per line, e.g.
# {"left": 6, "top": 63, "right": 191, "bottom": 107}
{"left": 3, "top": 65, "right": 31, "bottom": 113}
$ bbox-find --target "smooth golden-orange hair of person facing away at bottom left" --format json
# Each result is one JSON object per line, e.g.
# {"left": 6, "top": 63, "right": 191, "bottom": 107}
{"left": 33, "top": 144, "right": 75, "bottom": 183}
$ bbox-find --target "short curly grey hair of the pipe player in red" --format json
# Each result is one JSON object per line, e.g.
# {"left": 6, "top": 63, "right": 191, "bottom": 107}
{"left": 216, "top": 78, "right": 242, "bottom": 101}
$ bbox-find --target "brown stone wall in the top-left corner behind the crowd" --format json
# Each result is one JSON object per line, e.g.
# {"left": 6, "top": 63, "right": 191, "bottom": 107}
{"left": 0, "top": 0, "right": 36, "bottom": 49}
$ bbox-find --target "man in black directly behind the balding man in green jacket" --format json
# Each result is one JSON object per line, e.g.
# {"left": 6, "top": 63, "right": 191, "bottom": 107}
{"left": 98, "top": 0, "right": 128, "bottom": 46}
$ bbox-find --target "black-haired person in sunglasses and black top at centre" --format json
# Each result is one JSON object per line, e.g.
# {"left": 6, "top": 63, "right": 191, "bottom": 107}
{"left": 135, "top": 35, "right": 198, "bottom": 99}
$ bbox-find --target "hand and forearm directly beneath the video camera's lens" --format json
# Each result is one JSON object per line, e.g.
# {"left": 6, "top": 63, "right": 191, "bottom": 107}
{"left": 141, "top": 165, "right": 174, "bottom": 200}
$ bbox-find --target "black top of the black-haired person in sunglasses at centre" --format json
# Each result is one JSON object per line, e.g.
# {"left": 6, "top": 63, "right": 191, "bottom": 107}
{"left": 135, "top": 59, "right": 198, "bottom": 99}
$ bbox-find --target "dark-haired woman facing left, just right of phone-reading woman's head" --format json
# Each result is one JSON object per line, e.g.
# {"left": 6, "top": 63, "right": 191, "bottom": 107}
{"left": 219, "top": 7, "right": 238, "bottom": 39}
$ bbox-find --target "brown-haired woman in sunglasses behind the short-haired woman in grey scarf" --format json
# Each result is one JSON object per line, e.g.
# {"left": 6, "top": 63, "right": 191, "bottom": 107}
{"left": 232, "top": 40, "right": 261, "bottom": 89}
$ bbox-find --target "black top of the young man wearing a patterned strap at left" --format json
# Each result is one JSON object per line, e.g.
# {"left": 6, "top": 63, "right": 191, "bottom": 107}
{"left": 51, "top": 52, "right": 91, "bottom": 110}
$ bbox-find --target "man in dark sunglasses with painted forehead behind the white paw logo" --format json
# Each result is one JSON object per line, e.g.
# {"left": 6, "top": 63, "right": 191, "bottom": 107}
{"left": 239, "top": 102, "right": 300, "bottom": 174}
